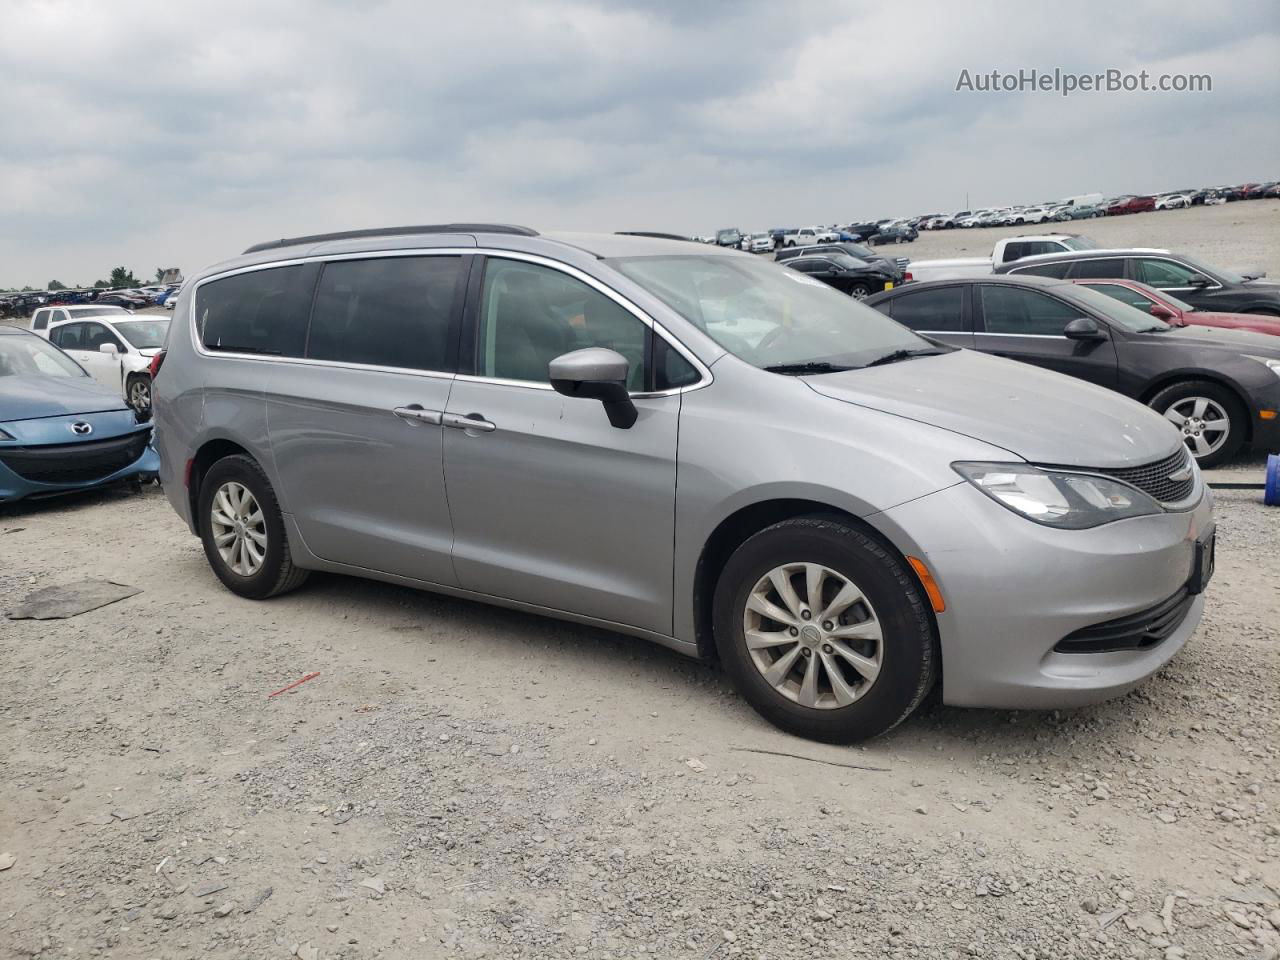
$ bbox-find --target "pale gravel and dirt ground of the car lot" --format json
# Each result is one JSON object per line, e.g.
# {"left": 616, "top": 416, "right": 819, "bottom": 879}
{"left": 0, "top": 202, "right": 1280, "bottom": 960}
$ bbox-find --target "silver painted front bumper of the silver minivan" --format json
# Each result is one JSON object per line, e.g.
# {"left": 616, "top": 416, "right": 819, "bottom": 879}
{"left": 869, "top": 483, "right": 1213, "bottom": 709}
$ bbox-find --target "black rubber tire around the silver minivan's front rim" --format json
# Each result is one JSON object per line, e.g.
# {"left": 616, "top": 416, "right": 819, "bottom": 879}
{"left": 714, "top": 516, "right": 940, "bottom": 744}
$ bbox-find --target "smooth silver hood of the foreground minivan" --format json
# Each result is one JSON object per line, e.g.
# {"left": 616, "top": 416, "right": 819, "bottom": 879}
{"left": 803, "top": 349, "right": 1180, "bottom": 467}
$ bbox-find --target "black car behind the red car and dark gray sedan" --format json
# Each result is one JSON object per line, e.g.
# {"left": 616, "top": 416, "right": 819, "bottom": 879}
{"left": 996, "top": 250, "right": 1280, "bottom": 316}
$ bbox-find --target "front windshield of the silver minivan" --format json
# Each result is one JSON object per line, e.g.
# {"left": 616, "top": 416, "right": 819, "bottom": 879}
{"left": 609, "top": 256, "right": 945, "bottom": 372}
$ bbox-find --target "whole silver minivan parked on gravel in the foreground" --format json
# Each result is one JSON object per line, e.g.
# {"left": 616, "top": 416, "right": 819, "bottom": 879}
{"left": 155, "top": 224, "right": 1213, "bottom": 742}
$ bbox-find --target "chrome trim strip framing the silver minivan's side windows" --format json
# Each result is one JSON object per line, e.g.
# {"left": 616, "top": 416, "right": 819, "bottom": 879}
{"left": 186, "top": 247, "right": 716, "bottom": 399}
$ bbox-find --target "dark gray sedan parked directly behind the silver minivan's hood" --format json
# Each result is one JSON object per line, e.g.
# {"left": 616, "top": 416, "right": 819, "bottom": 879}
{"left": 867, "top": 275, "right": 1280, "bottom": 467}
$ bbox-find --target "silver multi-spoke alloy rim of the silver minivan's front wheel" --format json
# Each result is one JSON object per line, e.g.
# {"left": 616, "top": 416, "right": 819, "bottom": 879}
{"left": 742, "top": 563, "right": 883, "bottom": 710}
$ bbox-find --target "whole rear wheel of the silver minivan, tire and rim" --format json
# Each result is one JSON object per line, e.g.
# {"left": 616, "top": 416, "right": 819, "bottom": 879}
{"left": 198, "top": 454, "right": 307, "bottom": 600}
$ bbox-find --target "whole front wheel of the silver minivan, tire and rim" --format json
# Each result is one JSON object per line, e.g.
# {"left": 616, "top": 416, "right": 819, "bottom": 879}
{"left": 714, "top": 516, "right": 938, "bottom": 744}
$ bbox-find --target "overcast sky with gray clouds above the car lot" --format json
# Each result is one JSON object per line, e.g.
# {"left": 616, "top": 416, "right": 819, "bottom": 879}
{"left": 0, "top": 0, "right": 1280, "bottom": 288}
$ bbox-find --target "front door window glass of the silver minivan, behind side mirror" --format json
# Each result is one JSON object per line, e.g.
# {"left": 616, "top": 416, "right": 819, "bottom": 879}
{"left": 476, "top": 259, "right": 649, "bottom": 392}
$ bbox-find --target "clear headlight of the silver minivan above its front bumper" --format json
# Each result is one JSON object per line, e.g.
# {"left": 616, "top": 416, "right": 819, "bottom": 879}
{"left": 951, "top": 463, "right": 1164, "bottom": 530}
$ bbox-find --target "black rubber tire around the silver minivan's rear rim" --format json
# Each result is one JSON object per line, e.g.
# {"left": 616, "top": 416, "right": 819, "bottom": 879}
{"left": 196, "top": 454, "right": 310, "bottom": 600}
